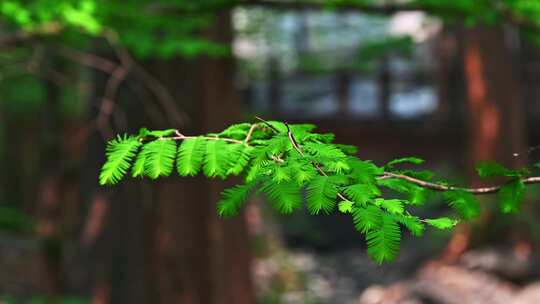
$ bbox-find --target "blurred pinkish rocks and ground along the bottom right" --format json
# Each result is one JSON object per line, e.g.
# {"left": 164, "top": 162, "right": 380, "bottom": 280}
{"left": 251, "top": 202, "right": 540, "bottom": 304}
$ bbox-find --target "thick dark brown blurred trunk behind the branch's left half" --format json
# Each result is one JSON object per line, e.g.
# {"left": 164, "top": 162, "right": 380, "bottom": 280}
{"left": 150, "top": 12, "right": 255, "bottom": 304}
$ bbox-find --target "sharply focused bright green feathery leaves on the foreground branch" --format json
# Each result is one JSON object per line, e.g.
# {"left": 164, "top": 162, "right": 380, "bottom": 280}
{"left": 99, "top": 121, "right": 540, "bottom": 263}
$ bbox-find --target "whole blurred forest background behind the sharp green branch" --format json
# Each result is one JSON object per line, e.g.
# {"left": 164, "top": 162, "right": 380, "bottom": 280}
{"left": 0, "top": 0, "right": 540, "bottom": 304}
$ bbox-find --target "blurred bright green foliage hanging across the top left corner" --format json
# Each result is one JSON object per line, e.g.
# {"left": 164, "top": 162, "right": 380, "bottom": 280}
{"left": 0, "top": 0, "right": 229, "bottom": 58}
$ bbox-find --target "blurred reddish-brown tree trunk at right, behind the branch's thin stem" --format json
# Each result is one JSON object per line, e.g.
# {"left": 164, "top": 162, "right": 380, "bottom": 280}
{"left": 440, "top": 27, "right": 527, "bottom": 260}
